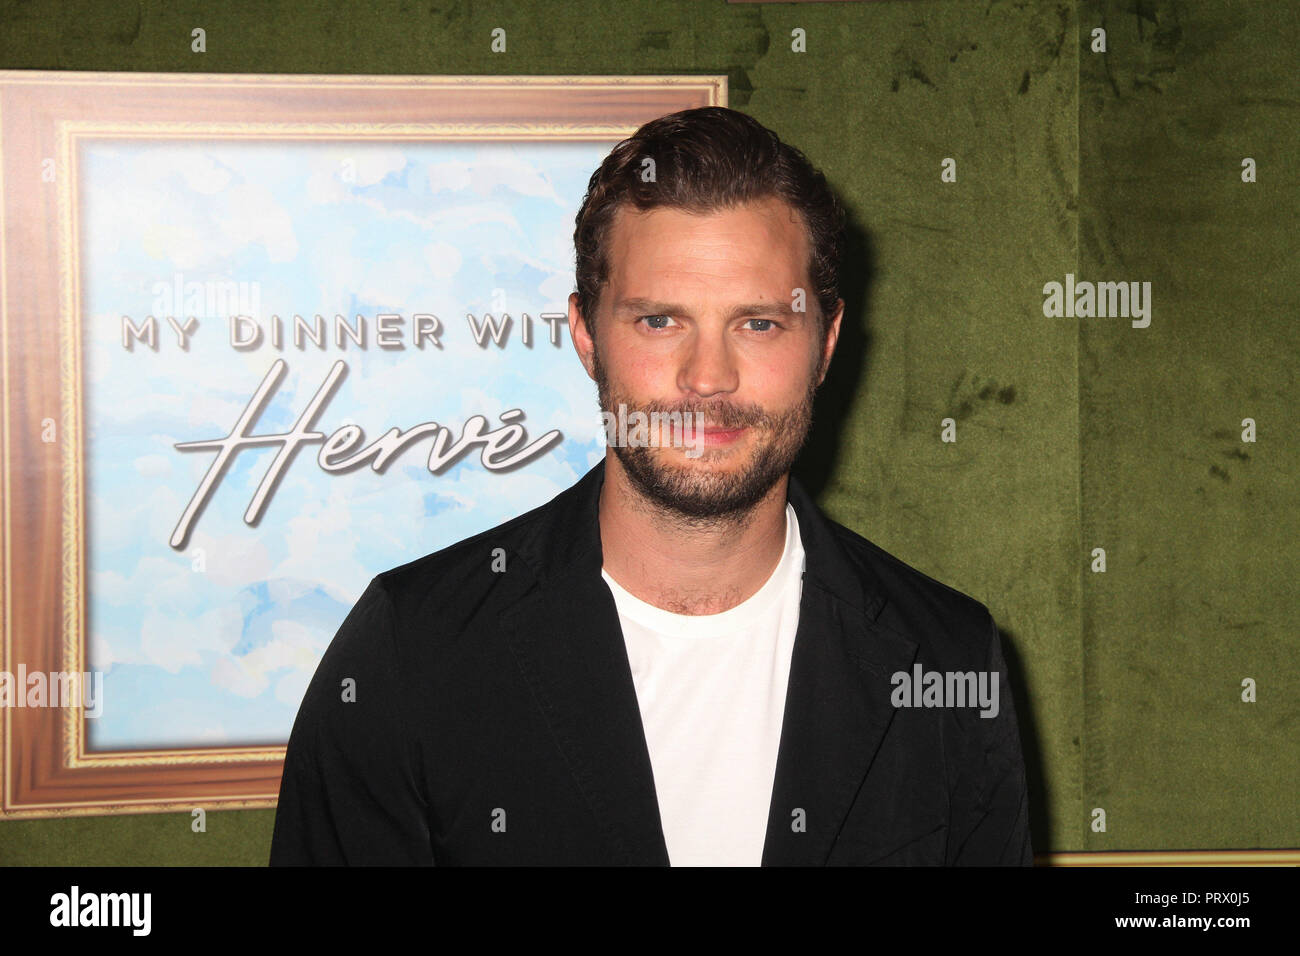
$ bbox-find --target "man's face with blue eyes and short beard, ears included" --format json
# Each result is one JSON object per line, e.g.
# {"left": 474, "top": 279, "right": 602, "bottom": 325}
{"left": 569, "top": 199, "right": 842, "bottom": 519}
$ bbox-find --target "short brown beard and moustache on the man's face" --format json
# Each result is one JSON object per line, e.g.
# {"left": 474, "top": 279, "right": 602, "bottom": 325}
{"left": 592, "top": 343, "right": 818, "bottom": 528}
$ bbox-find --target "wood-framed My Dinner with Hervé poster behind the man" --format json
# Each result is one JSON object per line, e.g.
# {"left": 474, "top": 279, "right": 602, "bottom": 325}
{"left": 0, "top": 72, "right": 727, "bottom": 817}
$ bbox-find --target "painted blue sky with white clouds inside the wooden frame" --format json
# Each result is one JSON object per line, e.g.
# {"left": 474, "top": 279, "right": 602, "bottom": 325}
{"left": 79, "top": 140, "right": 612, "bottom": 749}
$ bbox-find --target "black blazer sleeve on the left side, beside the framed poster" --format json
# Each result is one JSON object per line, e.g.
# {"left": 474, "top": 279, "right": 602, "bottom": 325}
{"left": 270, "top": 578, "right": 434, "bottom": 866}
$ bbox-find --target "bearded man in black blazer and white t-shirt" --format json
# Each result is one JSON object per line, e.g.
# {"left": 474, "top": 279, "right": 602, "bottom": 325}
{"left": 270, "top": 108, "right": 1031, "bottom": 865}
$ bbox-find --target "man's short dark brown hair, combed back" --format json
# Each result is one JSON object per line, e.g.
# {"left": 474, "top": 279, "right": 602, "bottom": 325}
{"left": 573, "top": 107, "right": 845, "bottom": 341}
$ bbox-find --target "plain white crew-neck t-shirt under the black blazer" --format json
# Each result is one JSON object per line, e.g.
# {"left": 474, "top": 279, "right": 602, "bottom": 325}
{"left": 601, "top": 502, "right": 805, "bottom": 866}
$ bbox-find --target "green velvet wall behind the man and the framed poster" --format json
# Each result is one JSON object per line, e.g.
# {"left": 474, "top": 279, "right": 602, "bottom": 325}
{"left": 0, "top": 0, "right": 1300, "bottom": 865}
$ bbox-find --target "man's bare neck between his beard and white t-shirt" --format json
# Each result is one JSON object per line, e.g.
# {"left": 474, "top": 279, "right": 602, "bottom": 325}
{"left": 599, "top": 454, "right": 789, "bottom": 614}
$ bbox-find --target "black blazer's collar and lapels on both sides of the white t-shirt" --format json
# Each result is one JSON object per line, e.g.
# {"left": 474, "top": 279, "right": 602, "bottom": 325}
{"left": 501, "top": 460, "right": 917, "bottom": 866}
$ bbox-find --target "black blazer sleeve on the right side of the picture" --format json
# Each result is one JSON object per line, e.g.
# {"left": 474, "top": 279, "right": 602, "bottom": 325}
{"left": 949, "top": 614, "right": 1034, "bottom": 866}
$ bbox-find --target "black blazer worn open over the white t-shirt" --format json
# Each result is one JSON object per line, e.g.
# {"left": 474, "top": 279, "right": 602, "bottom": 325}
{"left": 270, "top": 460, "right": 1032, "bottom": 866}
